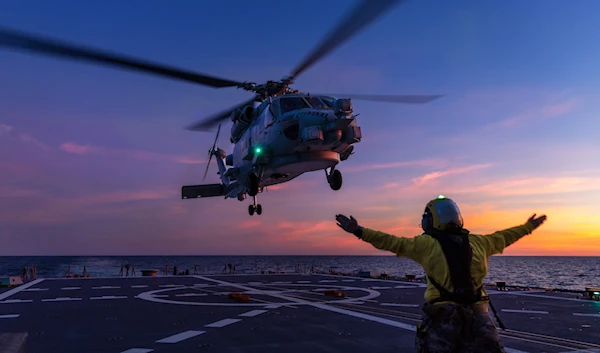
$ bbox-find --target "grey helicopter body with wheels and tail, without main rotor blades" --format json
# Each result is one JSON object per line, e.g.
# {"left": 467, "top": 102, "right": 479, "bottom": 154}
{"left": 182, "top": 93, "right": 362, "bottom": 215}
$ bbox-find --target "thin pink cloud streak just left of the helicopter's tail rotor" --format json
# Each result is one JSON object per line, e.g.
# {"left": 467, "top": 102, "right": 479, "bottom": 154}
{"left": 60, "top": 142, "right": 206, "bottom": 164}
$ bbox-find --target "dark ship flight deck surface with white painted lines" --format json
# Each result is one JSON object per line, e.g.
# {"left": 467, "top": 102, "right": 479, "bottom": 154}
{"left": 0, "top": 274, "right": 600, "bottom": 353}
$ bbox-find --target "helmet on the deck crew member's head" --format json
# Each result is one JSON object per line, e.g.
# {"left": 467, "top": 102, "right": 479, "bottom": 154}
{"left": 421, "top": 195, "right": 463, "bottom": 232}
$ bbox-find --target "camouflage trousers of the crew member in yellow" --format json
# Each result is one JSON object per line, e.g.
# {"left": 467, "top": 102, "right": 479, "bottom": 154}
{"left": 415, "top": 303, "right": 506, "bottom": 353}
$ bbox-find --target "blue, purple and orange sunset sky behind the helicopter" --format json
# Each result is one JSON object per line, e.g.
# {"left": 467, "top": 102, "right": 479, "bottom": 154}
{"left": 0, "top": 0, "right": 600, "bottom": 256}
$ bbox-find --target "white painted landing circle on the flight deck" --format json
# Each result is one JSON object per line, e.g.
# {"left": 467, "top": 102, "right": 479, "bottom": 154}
{"left": 136, "top": 283, "right": 381, "bottom": 307}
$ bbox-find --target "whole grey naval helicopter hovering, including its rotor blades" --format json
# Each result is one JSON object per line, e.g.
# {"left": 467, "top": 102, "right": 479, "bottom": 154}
{"left": 0, "top": 0, "right": 443, "bottom": 216}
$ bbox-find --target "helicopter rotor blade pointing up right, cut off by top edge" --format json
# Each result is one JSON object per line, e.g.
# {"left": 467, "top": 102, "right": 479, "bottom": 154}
{"left": 291, "top": 0, "right": 404, "bottom": 80}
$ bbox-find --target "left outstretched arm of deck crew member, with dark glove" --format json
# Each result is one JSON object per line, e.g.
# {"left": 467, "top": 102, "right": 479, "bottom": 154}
{"left": 336, "top": 215, "right": 427, "bottom": 263}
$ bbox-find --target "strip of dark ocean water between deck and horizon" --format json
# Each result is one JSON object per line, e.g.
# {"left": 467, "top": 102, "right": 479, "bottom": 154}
{"left": 0, "top": 256, "right": 600, "bottom": 290}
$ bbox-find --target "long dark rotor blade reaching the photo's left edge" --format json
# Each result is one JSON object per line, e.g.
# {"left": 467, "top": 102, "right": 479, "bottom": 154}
{"left": 0, "top": 28, "right": 243, "bottom": 87}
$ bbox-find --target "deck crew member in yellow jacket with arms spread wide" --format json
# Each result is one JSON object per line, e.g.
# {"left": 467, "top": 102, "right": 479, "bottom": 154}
{"left": 336, "top": 195, "right": 546, "bottom": 353}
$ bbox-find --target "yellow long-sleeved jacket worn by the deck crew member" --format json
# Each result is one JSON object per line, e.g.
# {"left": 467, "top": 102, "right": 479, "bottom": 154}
{"left": 361, "top": 222, "right": 534, "bottom": 304}
